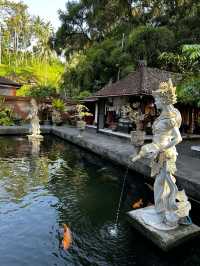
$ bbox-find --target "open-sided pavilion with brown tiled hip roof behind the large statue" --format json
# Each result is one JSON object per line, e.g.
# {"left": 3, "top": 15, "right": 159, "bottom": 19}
{"left": 84, "top": 60, "right": 199, "bottom": 134}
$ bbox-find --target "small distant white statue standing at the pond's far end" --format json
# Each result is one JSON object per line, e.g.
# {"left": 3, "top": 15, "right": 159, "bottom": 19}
{"left": 27, "top": 99, "right": 43, "bottom": 139}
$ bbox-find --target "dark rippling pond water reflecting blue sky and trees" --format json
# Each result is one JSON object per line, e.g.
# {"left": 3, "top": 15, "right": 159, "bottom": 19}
{"left": 0, "top": 136, "right": 200, "bottom": 266}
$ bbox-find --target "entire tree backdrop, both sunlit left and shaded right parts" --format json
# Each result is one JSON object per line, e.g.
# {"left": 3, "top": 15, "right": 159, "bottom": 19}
{"left": 0, "top": 0, "right": 200, "bottom": 101}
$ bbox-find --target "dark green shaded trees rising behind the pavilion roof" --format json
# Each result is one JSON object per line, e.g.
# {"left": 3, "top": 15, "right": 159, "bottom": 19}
{"left": 55, "top": 0, "right": 200, "bottom": 100}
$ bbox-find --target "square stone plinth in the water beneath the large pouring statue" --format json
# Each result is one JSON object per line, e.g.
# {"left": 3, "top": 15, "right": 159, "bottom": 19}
{"left": 127, "top": 207, "right": 200, "bottom": 251}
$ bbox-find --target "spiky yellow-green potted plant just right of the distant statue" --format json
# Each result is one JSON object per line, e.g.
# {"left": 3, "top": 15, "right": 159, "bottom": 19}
{"left": 52, "top": 99, "right": 65, "bottom": 126}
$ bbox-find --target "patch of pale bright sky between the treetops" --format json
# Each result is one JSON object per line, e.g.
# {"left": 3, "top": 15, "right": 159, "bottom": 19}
{"left": 15, "top": 0, "right": 67, "bottom": 30}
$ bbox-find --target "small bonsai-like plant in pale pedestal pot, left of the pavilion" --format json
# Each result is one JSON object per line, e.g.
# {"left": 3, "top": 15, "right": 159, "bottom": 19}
{"left": 75, "top": 104, "right": 92, "bottom": 137}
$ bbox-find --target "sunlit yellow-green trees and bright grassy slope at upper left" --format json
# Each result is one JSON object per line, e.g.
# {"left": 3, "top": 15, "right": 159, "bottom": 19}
{"left": 0, "top": 0, "right": 64, "bottom": 97}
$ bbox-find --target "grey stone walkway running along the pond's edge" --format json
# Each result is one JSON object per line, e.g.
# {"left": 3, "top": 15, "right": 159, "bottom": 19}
{"left": 0, "top": 126, "right": 200, "bottom": 201}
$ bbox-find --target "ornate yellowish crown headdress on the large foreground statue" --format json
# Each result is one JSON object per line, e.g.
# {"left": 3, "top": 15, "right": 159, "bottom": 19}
{"left": 153, "top": 79, "right": 177, "bottom": 104}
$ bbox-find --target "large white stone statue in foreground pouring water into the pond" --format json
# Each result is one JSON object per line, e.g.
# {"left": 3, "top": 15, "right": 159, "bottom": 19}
{"left": 132, "top": 80, "right": 191, "bottom": 230}
